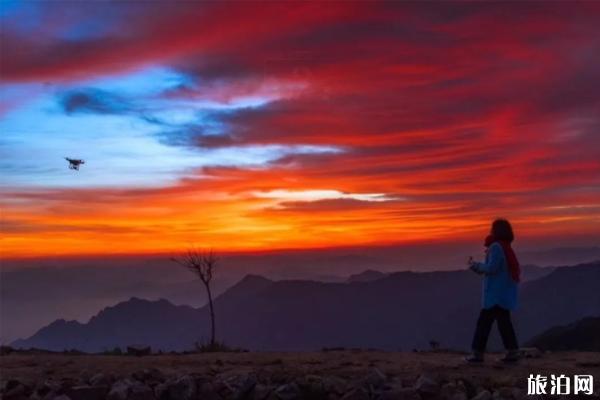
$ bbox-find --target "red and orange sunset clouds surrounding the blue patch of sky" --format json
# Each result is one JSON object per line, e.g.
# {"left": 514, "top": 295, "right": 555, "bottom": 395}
{"left": 0, "top": 2, "right": 600, "bottom": 252}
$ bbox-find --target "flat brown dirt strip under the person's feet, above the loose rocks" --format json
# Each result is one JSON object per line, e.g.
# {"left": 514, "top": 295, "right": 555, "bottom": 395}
{"left": 0, "top": 350, "right": 600, "bottom": 388}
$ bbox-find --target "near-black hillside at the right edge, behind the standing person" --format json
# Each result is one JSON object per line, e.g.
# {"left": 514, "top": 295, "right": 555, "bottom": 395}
{"left": 527, "top": 318, "right": 600, "bottom": 351}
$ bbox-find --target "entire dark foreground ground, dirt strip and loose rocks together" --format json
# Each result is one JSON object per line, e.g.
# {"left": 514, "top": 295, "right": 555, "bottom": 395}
{"left": 0, "top": 350, "right": 600, "bottom": 400}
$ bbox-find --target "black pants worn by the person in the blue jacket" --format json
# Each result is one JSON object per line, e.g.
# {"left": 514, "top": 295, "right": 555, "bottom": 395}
{"left": 471, "top": 306, "right": 519, "bottom": 353}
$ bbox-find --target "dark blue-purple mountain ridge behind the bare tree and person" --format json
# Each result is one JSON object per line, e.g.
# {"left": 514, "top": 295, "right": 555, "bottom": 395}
{"left": 13, "top": 263, "right": 600, "bottom": 351}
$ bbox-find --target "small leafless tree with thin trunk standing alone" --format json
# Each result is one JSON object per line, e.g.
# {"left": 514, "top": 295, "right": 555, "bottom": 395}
{"left": 171, "top": 248, "right": 219, "bottom": 347}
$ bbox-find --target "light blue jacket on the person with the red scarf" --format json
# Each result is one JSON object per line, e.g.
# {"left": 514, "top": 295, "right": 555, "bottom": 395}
{"left": 471, "top": 242, "right": 518, "bottom": 310}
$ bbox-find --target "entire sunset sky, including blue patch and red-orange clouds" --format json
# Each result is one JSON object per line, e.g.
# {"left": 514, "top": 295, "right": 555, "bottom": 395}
{"left": 0, "top": 0, "right": 600, "bottom": 258}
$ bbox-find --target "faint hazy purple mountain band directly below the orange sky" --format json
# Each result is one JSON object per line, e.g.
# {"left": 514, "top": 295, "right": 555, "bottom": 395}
{"left": 0, "top": 247, "right": 600, "bottom": 344}
